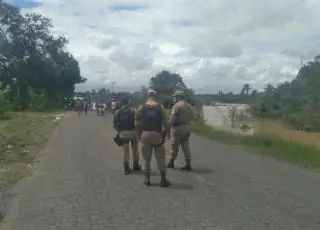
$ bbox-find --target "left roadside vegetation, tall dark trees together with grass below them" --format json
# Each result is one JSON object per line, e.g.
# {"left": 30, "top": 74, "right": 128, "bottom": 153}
{"left": 0, "top": 0, "right": 86, "bottom": 188}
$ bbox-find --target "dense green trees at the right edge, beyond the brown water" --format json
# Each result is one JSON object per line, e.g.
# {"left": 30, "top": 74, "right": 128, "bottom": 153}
{"left": 252, "top": 55, "right": 320, "bottom": 131}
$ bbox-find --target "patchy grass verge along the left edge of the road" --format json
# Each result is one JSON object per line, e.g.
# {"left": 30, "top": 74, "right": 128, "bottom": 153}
{"left": 0, "top": 112, "right": 61, "bottom": 188}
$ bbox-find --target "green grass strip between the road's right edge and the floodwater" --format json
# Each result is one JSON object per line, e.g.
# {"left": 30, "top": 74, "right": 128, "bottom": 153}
{"left": 192, "top": 122, "right": 320, "bottom": 171}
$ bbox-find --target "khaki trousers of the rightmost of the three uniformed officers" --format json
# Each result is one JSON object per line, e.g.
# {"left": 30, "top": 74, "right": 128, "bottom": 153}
{"left": 170, "top": 128, "right": 191, "bottom": 161}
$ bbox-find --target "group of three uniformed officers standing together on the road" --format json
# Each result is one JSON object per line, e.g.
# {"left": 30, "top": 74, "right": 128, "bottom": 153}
{"left": 113, "top": 89, "right": 194, "bottom": 187}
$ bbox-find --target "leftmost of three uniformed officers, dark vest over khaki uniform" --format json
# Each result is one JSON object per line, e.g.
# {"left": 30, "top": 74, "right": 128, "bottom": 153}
{"left": 113, "top": 97, "right": 141, "bottom": 175}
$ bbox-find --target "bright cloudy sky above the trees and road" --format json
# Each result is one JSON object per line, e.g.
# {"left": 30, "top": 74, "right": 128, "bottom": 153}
{"left": 6, "top": 0, "right": 320, "bottom": 93}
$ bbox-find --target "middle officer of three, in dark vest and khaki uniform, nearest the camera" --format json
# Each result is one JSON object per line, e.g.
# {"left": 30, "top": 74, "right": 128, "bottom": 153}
{"left": 136, "top": 89, "right": 171, "bottom": 187}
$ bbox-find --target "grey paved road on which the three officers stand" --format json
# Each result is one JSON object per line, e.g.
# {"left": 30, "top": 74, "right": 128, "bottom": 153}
{"left": 3, "top": 114, "right": 320, "bottom": 230}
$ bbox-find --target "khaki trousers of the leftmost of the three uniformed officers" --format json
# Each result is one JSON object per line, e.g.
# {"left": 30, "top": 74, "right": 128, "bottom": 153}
{"left": 119, "top": 131, "right": 139, "bottom": 163}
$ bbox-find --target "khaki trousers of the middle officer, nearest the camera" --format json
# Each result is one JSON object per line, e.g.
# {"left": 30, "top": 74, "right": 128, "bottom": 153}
{"left": 140, "top": 132, "right": 166, "bottom": 173}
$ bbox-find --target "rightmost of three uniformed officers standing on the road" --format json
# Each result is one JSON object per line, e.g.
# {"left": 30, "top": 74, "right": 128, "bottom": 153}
{"left": 167, "top": 91, "right": 193, "bottom": 171}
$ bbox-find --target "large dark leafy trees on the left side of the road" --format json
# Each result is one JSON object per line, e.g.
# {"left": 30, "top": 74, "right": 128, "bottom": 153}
{"left": 0, "top": 0, "right": 86, "bottom": 117}
